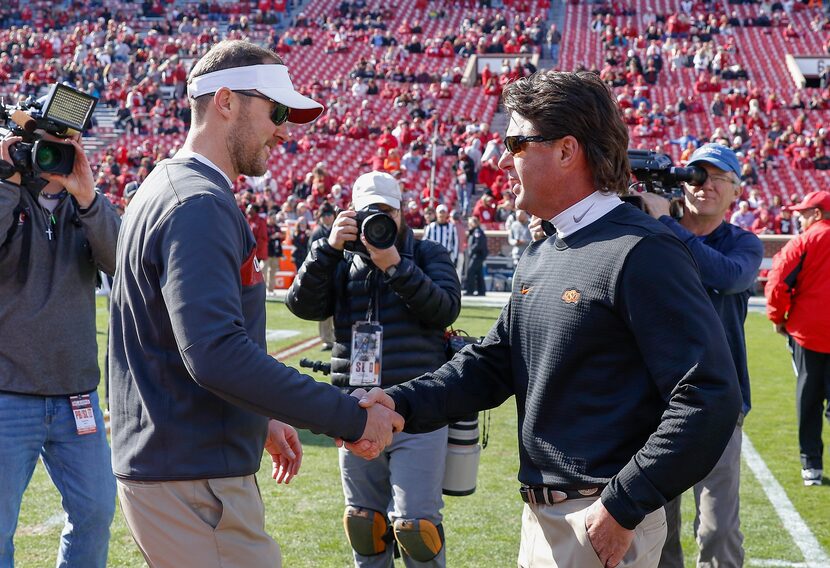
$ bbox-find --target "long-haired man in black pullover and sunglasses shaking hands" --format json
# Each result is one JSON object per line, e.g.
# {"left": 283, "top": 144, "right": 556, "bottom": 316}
{"left": 370, "top": 72, "right": 741, "bottom": 568}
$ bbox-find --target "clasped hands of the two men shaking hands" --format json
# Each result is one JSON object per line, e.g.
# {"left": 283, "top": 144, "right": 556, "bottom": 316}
{"left": 336, "top": 387, "right": 404, "bottom": 460}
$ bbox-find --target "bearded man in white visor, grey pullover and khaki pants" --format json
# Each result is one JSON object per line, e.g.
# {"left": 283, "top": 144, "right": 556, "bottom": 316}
{"left": 109, "top": 40, "right": 402, "bottom": 568}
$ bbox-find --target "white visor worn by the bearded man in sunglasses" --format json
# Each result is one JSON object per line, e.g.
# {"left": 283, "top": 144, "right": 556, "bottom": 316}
{"left": 187, "top": 63, "right": 325, "bottom": 124}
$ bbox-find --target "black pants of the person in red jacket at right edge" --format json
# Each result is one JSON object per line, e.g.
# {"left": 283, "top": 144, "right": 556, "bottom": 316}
{"left": 789, "top": 337, "right": 830, "bottom": 469}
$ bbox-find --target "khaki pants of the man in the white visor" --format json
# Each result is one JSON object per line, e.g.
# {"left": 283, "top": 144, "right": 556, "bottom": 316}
{"left": 118, "top": 475, "right": 282, "bottom": 568}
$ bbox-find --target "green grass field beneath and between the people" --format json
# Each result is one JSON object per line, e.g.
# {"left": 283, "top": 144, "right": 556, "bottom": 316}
{"left": 15, "top": 299, "right": 830, "bottom": 568}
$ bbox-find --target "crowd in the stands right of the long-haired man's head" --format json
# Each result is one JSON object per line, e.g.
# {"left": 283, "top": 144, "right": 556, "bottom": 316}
{"left": 575, "top": 0, "right": 830, "bottom": 234}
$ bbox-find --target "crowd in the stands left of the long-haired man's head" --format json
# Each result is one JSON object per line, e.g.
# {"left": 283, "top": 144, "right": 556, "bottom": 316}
{"left": 0, "top": 0, "right": 546, "bottom": 255}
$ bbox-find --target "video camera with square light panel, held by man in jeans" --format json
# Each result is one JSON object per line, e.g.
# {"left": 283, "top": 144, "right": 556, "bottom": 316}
{"left": 0, "top": 84, "right": 98, "bottom": 185}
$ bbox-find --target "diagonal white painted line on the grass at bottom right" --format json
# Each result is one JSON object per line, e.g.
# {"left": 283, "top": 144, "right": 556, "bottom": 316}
{"left": 741, "top": 433, "right": 830, "bottom": 568}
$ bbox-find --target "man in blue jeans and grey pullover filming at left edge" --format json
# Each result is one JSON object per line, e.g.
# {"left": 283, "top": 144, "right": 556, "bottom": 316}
{"left": 0, "top": 131, "right": 120, "bottom": 567}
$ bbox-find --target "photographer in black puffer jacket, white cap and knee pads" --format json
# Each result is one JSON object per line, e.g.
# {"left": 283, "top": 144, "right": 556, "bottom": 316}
{"left": 286, "top": 172, "right": 461, "bottom": 568}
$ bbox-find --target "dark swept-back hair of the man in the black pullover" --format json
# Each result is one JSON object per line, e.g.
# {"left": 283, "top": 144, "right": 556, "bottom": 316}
{"left": 504, "top": 71, "right": 630, "bottom": 193}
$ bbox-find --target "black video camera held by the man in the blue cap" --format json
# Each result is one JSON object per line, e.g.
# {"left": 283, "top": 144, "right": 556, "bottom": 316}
{"left": 622, "top": 150, "right": 708, "bottom": 219}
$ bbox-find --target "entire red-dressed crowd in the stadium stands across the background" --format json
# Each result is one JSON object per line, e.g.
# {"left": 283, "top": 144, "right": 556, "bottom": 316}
{"left": 0, "top": 0, "right": 830, "bottom": 290}
